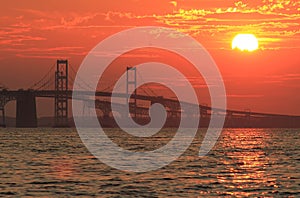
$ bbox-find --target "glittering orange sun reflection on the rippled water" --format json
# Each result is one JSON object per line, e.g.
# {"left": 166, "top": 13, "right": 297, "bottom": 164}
{"left": 217, "top": 129, "right": 278, "bottom": 196}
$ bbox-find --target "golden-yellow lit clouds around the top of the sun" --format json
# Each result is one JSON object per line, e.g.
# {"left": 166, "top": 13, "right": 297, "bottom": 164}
{"left": 157, "top": 0, "right": 300, "bottom": 49}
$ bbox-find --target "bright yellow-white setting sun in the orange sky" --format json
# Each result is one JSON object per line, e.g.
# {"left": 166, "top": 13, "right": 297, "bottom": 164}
{"left": 231, "top": 34, "right": 258, "bottom": 52}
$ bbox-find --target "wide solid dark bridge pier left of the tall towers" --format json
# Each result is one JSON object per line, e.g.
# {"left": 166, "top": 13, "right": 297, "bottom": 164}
{"left": 16, "top": 91, "right": 37, "bottom": 128}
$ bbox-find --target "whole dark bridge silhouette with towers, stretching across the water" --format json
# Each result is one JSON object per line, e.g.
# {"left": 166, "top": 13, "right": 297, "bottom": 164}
{"left": 0, "top": 60, "right": 300, "bottom": 128}
